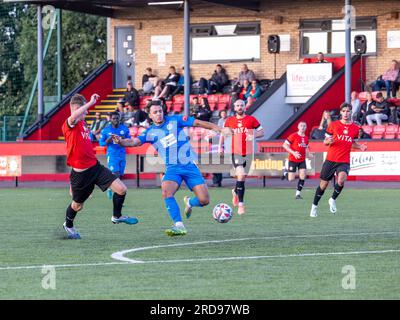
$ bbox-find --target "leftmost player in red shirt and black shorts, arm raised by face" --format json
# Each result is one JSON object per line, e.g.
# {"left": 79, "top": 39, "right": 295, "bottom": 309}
{"left": 62, "top": 94, "right": 138, "bottom": 239}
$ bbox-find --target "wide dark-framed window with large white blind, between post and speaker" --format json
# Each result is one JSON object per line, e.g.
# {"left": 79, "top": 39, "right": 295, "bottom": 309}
{"left": 190, "top": 22, "right": 261, "bottom": 63}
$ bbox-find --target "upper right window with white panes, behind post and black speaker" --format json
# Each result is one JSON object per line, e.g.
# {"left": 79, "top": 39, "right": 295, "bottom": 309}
{"left": 300, "top": 17, "right": 376, "bottom": 56}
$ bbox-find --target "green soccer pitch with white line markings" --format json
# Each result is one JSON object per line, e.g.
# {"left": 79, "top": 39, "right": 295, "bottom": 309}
{"left": 0, "top": 188, "right": 400, "bottom": 300}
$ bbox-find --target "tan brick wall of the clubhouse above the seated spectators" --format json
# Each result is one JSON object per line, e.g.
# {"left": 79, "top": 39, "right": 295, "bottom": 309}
{"left": 109, "top": 0, "right": 400, "bottom": 90}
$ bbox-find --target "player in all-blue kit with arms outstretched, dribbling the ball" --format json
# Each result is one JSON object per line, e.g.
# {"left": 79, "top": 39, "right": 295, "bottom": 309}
{"left": 114, "top": 103, "right": 231, "bottom": 237}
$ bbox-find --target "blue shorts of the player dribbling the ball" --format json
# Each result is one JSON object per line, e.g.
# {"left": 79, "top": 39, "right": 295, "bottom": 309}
{"left": 162, "top": 163, "right": 205, "bottom": 191}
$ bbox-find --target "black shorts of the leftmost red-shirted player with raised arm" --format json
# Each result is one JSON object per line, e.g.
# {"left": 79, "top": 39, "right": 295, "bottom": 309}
{"left": 69, "top": 162, "right": 118, "bottom": 203}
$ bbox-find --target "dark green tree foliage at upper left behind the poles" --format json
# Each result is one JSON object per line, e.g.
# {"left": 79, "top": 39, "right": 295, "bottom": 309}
{"left": 0, "top": 4, "right": 107, "bottom": 120}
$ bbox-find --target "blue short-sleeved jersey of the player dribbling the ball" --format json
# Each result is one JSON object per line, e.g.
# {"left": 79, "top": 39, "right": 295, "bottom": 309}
{"left": 138, "top": 116, "right": 197, "bottom": 167}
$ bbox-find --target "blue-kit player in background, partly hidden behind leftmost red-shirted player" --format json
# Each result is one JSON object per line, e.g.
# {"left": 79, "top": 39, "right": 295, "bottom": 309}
{"left": 99, "top": 112, "right": 131, "bottom": 199}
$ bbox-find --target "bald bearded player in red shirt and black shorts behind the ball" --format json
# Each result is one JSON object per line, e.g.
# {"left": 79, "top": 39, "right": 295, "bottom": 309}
{"left": 219, "top": 99, "right": 264, "bottom": 215}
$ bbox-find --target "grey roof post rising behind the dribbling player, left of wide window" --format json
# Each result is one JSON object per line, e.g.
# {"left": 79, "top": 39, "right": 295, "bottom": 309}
{"left": 183, "top": 0, "right": 190, "bottom": 116}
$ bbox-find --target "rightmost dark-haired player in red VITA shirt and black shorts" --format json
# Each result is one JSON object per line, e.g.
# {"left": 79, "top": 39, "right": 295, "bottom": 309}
{"left": 310, "top": 102, "right": 367, "bottom": 217}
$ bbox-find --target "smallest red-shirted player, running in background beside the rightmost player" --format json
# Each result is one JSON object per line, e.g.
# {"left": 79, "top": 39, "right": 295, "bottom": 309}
{"left": 282, "top": 121, "right": 308, "bottom": 199}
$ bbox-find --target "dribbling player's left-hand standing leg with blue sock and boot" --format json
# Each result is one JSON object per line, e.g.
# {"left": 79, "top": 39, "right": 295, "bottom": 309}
{"left": 161, "top": 180, "right": 187, "bottom": 237}
